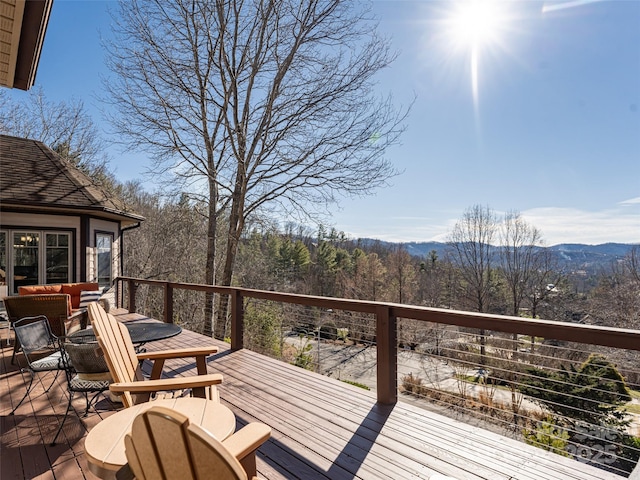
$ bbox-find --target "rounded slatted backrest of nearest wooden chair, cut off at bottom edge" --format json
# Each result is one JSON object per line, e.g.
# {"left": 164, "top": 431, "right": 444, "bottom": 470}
{"left": 124, "top": 407, "right": 247, "bottom": 480}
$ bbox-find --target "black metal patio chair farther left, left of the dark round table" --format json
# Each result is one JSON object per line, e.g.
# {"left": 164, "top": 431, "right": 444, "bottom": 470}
{"left": 9, "top": 315, "right": 64, "bottom": 415}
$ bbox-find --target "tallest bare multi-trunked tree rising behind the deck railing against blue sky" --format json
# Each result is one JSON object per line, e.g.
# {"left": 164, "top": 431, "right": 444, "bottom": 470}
{"left": 105, "top": 0, "right": 404, "bottom": 337}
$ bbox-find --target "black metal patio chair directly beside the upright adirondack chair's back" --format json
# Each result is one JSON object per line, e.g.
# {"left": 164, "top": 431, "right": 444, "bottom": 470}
{"left": 51, "top": 342, "right": 111, "bottom": 445}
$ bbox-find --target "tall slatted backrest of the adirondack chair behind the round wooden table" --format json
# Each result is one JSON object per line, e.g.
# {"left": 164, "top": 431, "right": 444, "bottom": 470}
{"left": 88, "top": 302, "right": 141, "bottom": 407}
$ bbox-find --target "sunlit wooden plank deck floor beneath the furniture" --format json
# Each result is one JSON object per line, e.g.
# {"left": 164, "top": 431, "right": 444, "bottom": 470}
{"left": 0, "top": 317, "right": 622, "bottom": 480}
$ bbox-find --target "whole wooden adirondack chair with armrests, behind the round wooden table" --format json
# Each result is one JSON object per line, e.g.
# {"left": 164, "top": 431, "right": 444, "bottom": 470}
{"left": 88, "top": 303, "right": 222, "bottom": 407}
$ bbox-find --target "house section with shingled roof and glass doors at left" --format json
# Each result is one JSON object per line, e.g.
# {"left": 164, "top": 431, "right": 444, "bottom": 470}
{"left": 0, "top": 135, "right": 144, "bottom": 296}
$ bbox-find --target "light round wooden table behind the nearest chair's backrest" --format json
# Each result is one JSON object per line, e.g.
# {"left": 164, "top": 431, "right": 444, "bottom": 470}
{"left": 84, "top": 397, "right": 236, "bottom": 479}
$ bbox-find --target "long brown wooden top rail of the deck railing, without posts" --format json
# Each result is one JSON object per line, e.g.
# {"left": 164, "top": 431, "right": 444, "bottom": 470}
{"left": 117, "top": 277, "right": 640, "bottom": 351}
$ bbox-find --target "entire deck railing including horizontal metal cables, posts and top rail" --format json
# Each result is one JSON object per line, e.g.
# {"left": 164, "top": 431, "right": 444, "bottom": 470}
{"left": 116, "top": 279, "right": 640, "bottom": 475}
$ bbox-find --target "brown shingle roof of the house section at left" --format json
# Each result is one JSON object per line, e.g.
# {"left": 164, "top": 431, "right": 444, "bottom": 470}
{"left": 0, "top": 135, "right": 143, "bottom": 226}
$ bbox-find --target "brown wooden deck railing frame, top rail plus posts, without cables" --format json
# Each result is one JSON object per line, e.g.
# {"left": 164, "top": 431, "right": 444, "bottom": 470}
{"left": 116, "top": 277, "right": 640, "bottom": 404}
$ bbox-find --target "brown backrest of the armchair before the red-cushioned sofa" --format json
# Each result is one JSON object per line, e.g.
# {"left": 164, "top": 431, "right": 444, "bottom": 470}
{"left": 4, "top": 293, "right": 69, "bottom": 337}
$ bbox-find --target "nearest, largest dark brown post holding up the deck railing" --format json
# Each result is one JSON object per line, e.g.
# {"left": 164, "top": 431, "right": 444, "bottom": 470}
{"left": 376, "top": 305, "right": 398, "bottom": 404}
